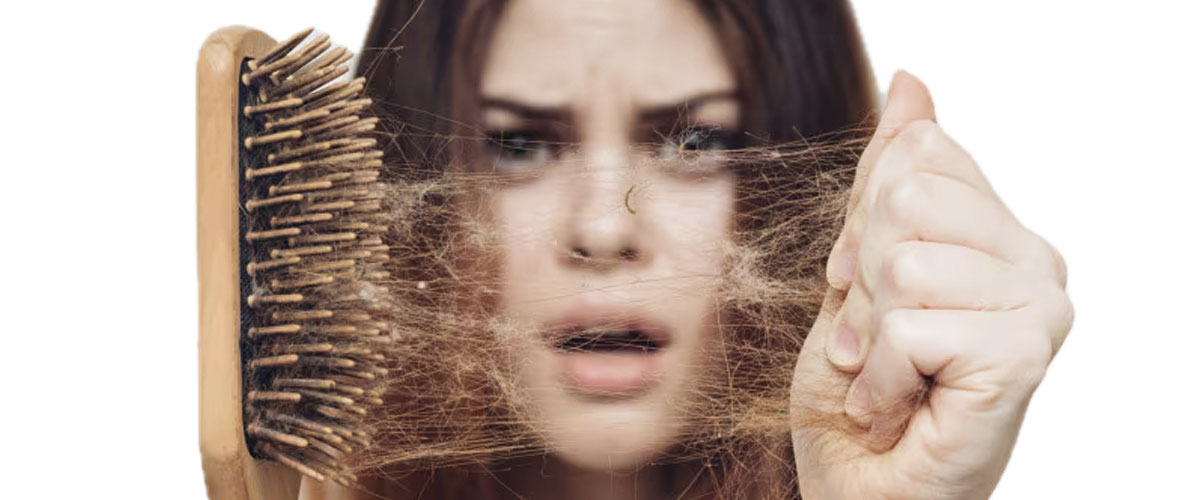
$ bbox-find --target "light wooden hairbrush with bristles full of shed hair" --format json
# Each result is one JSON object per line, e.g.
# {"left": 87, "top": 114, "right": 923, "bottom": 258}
{"left": 197, "top": 26, "right": 389, "bottom": 499}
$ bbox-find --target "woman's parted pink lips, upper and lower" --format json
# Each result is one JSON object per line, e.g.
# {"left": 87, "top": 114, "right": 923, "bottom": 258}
{"left": 545, "top": 307, "right": 671, "bottom": 398}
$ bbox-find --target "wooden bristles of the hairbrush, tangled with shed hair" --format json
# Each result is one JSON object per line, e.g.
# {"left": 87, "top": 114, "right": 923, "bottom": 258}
{"left": 239, "top": 30, "right": 389, "bottom": 484}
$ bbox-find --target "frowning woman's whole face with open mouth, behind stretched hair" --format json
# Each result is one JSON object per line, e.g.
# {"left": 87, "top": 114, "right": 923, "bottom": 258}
{"left": 480, "top": 0, "right": 740, "bottom": 469}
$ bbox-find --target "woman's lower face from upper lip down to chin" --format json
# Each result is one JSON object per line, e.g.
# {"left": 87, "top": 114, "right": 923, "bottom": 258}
{"left": 512, "top": 299, "right": 706, "bottom": 470}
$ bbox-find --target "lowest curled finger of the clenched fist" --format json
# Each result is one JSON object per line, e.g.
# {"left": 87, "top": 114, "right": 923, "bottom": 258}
{"left": 846, "top": 309, "right": 1051, "bottom": 451}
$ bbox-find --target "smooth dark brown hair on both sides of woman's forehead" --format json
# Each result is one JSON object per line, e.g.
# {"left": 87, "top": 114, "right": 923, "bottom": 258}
{"left": 358, "top": 0, "right": 876, "bottom": 158}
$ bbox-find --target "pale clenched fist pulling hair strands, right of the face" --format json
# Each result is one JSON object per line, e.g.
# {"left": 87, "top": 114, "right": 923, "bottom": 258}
{"left": 792, "top": 72, "right": 1073, "bottom": 500}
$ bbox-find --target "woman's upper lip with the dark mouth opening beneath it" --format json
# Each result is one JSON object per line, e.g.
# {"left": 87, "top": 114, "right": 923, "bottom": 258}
{"left": 544, "top": 307, "right": 671, "bottom": 351}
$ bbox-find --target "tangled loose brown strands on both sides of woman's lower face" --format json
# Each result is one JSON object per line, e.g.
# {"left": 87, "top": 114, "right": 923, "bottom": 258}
{"left": 338, "top": 113, "right": 866, "bottom": 498}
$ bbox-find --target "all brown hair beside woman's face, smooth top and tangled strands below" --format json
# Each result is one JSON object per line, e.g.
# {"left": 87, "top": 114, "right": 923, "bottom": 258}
{"left": 355, "top": 0, "right": 876, "bottom": 498}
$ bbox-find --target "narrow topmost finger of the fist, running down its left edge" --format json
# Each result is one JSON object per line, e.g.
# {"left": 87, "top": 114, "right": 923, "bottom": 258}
{"left": 826, "top": 71, "right": 936, "bottom": 290}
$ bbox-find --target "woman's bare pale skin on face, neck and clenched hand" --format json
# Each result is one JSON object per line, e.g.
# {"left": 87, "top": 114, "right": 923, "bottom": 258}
{"left": 302, "top": 0, "right": 1072, "bottom": 500}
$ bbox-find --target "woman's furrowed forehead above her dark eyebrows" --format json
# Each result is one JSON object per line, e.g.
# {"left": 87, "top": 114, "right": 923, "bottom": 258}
{"left": 481, "top": 0, "right": 734, "bottom": 107}
